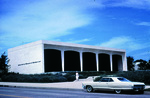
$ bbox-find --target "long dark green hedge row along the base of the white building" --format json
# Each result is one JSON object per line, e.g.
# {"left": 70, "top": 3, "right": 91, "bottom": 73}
{"left": 0, "top": 71, "right": 150, "bottom": 84}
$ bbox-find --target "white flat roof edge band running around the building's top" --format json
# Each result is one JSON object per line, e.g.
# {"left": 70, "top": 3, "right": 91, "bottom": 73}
{"left": 8, "top": 40, "right": 126, "bottom": 52}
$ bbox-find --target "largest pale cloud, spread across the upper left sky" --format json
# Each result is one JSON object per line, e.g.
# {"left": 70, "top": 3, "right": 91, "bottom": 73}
{"left": 0, "top": 0, "right": 95, "bottom": 48}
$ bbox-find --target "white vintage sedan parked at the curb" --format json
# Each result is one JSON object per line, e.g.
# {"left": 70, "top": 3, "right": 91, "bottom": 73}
{"left": 82, "top": 77, "right": 145, "bottom": 94}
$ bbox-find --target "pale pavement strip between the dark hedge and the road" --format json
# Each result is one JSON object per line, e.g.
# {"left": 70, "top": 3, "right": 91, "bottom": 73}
{"left": 0, "top": 78, "right": 150, "bottom": 90}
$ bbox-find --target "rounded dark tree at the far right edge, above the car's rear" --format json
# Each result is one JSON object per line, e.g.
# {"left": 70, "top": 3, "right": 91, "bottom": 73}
{"left": 135, "top": 59, "right": 149, "bottom": 70}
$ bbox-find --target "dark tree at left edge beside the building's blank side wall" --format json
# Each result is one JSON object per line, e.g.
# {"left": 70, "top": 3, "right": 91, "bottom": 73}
{"left": 0, "top": 52, "right": 9, "bottom": 73}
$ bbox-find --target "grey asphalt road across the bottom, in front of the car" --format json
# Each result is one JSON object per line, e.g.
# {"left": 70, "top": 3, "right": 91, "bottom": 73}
{"left": 0, "top": 87, "right": 150, "bottom": 98}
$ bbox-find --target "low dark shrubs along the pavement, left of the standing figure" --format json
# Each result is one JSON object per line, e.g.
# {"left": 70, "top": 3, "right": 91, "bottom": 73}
{"left": 2, "top": 74, "right": 67, "bottom": 82}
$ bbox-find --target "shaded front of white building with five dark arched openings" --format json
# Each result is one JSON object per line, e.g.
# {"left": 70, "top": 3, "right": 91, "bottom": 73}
{"left": 44, "top": 46, "right": 124, "bottom": 72}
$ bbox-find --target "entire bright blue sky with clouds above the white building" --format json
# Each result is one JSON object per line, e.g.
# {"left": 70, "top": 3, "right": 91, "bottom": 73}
{"left": 0, "top": 0, "right": 150, "bottom": 60}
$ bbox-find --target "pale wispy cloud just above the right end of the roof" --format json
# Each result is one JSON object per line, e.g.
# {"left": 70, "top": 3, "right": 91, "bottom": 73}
{"left": 99, "top": 36, "right": 145, "bottom": 52}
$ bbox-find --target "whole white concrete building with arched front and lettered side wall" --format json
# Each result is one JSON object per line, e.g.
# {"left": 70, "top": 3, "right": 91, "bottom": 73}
{"left": 8, "top": 40, "right": 127, "bottom": 74}
